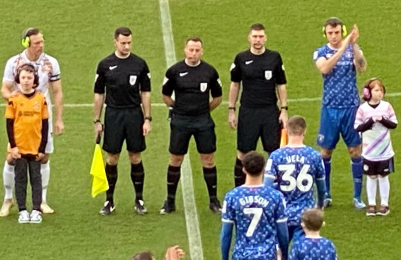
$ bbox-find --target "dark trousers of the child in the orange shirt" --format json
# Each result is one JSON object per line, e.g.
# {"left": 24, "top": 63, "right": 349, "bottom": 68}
{"left": 15, "top": 155, "right": 42, "bottom": 211}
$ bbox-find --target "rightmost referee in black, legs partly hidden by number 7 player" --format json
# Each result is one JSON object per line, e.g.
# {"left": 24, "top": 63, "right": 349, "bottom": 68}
{"left": 228, "top": 23, "right": 288, "bottom": 187}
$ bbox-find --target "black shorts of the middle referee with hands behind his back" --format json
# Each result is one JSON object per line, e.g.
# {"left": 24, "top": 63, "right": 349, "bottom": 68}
{"left": 169, "top": 114, "right": 216, "bottom": 155}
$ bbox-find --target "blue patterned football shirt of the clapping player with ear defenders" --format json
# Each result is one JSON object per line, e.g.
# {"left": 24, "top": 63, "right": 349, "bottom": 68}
{"left": 313, "top": 44, "right": 359, "bottom": 108}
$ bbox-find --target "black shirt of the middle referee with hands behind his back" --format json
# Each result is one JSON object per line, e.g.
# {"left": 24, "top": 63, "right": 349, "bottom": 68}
{"left": 162, "top": 60, "right": 222, "bottom": 116}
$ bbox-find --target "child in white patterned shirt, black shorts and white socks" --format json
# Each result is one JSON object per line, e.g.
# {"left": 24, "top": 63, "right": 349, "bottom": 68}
{"left": 354, "top": 78, "right": 398, "bottom": 216}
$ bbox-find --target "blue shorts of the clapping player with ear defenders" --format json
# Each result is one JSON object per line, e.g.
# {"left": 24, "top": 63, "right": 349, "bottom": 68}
{"left": 317, "top": 107, "right": 361, "bottom": 150}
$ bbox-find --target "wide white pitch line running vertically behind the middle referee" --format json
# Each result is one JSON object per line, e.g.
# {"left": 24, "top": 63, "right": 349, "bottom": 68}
{"left": 159, "top": 0, "right": 204, "bottom": 260}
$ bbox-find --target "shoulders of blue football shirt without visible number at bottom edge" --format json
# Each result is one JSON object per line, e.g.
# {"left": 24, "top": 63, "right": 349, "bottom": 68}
{"left": 289, "top": 237, "right": 337, "bottom": 260}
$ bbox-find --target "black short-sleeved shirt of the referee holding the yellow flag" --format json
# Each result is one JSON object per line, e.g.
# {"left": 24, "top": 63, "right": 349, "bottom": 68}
{"left": 94, "top": 53, "right": 150, "bottom": 108}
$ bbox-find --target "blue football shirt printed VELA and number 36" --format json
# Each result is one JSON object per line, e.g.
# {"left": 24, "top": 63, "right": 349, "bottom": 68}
{"left": 265, "top": 145, "right": 325, "bottom": 226}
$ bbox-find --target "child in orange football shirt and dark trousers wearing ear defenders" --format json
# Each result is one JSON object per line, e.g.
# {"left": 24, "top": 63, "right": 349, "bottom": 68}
{"left": 5, "top": 64, "right": 49, "bottom": 223}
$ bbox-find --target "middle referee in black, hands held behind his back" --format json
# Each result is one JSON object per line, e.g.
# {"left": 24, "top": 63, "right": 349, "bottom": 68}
{"left": 160, "top": 37, "right": 222, "bottom": 214}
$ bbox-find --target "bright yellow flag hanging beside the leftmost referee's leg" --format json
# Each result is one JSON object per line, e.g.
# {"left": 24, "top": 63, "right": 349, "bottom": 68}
{"left": 91, "top": 143, "right": 109, "bottom": 198}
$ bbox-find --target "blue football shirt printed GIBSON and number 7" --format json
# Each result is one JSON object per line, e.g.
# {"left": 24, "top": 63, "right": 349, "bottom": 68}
{"left": 222, "top": 184, "right": 287, "bottom": 260}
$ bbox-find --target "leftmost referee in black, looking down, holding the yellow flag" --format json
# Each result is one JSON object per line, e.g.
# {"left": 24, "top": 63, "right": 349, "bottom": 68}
{"left": 94, "top": 27, "right": 152, "bottom": 215}
